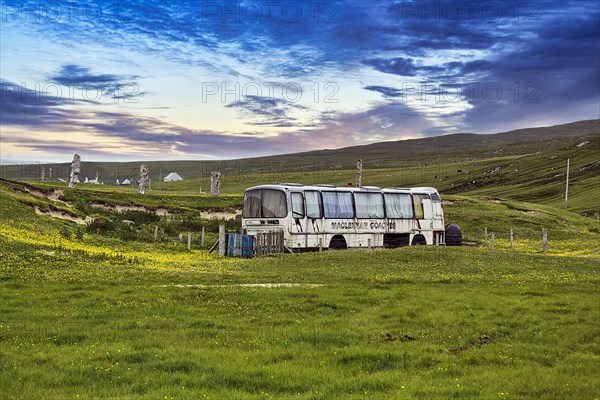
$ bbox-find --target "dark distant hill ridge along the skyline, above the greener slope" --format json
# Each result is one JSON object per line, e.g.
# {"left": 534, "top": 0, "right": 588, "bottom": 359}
{"left": 0, "top": 120, "right": 600, "bottom": 179}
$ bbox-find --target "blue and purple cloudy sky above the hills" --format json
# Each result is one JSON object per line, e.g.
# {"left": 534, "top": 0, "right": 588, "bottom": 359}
{"left": 0, "top": 0, "right": 600, "bottom": 163}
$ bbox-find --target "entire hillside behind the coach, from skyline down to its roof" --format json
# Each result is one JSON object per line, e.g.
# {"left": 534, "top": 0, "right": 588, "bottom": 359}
{"left": 2, "top": 120, "right": 600, "bottom": 217}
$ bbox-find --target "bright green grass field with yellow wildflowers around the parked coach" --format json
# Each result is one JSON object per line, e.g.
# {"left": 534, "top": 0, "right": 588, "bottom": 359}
{"left": 0, "top": 182, "right": 600, "bottom": 399}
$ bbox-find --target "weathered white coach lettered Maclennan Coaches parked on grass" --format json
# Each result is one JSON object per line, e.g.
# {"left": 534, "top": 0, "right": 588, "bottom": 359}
{"left": 242, "top": 183, "right": 444, "bottom": 251}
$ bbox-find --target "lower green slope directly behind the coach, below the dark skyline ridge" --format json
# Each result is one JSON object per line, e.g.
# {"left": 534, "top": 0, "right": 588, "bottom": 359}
{"left": 43, "top": 137, "right": 600, "bottom": 218}
